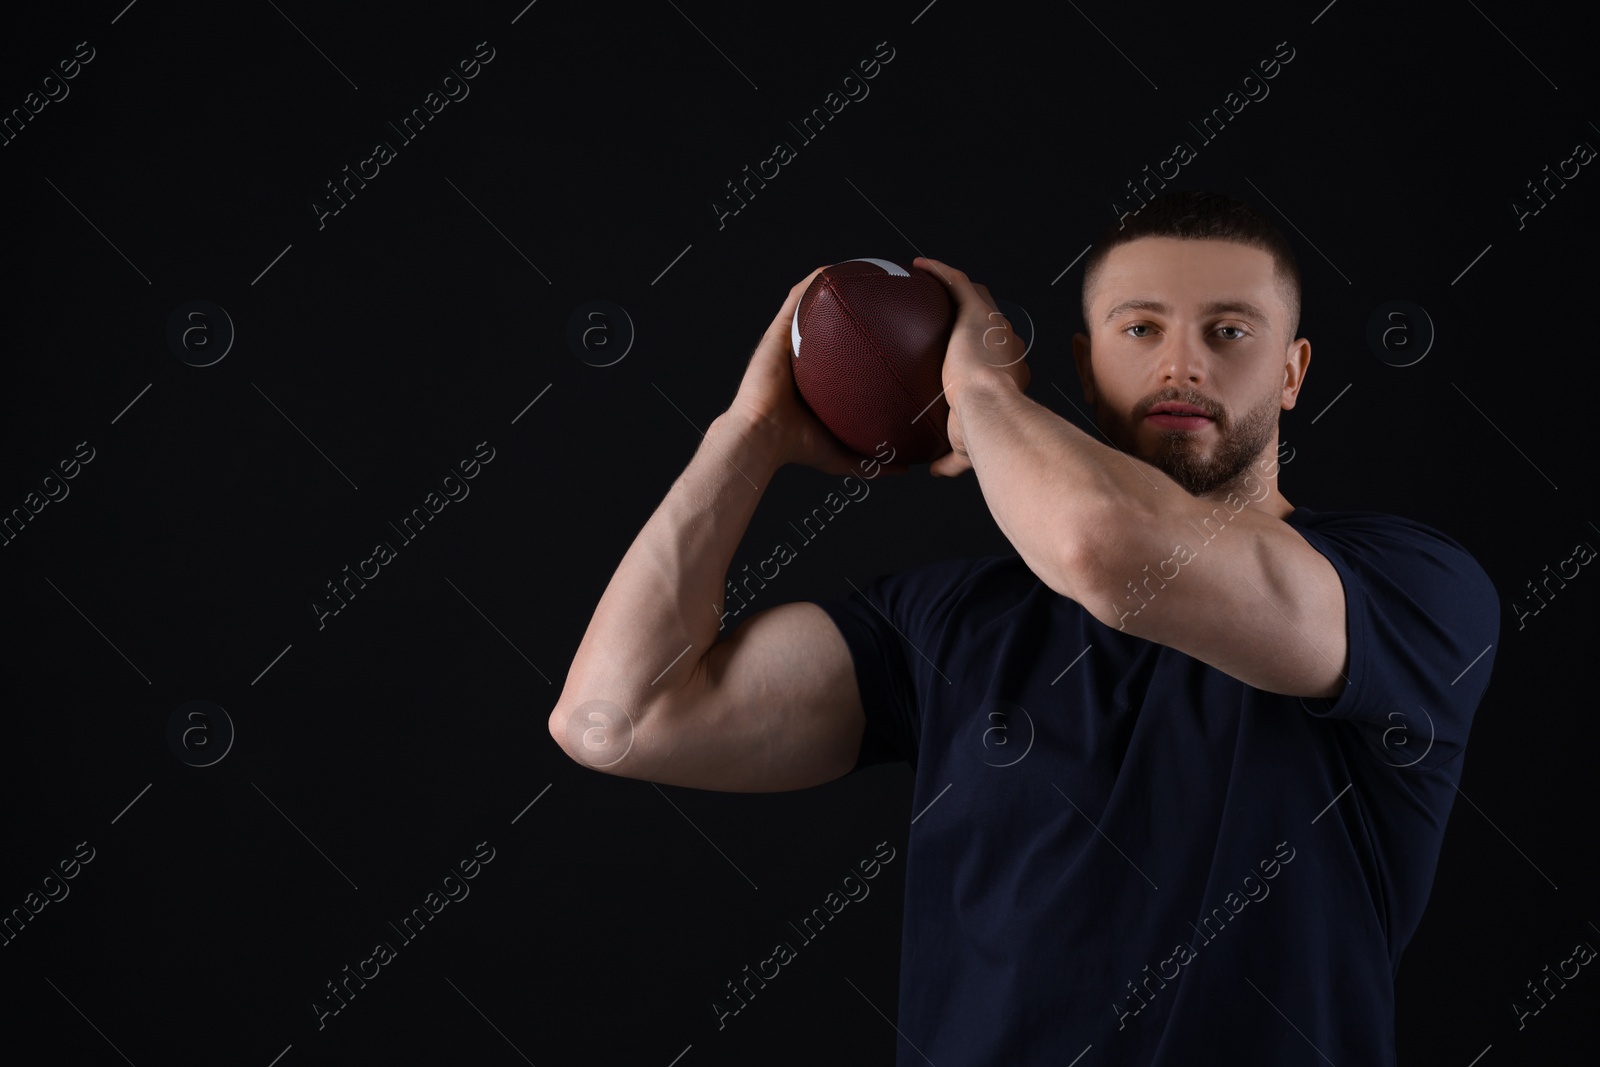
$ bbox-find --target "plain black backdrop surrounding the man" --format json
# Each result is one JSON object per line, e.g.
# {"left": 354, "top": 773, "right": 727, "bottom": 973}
{"left": 0, "top": 0, "right": 1600, "bottom": 1067}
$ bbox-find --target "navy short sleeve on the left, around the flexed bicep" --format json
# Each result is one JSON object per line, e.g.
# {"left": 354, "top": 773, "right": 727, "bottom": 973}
{"left": 796, "top": 560, "right": 982, "bottom": 771}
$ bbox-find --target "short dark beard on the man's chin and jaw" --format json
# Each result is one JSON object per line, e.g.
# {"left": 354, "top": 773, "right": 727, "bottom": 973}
{"left": 1094, "top": 389, "right": 1280, "bottom": 496}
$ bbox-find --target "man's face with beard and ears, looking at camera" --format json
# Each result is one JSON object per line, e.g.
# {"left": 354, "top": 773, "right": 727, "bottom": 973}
{"left": 1074, "top": 237, "right": 1310, "bottom": 496}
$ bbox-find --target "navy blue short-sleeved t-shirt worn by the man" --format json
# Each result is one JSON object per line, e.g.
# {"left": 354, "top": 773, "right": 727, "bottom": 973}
{"left": 811, "top": 507, "right": 1499, "bottom": 1067}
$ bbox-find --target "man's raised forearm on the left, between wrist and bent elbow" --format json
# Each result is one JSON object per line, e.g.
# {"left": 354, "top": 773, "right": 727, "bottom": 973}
{"left": 557, "top": 414, "right": 782, "bottom": 717}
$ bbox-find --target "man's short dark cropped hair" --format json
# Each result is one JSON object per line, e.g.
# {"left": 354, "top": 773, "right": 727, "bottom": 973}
{"left": 1082, "top": 190, "right": 1301, "bottom": 341}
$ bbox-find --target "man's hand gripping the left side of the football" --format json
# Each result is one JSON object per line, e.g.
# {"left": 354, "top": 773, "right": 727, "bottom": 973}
{"left": 725, "top": 267, "right": 909, "bottom": 475}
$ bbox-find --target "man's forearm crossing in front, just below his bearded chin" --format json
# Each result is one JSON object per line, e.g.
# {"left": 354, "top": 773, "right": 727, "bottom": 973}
{"left": 955, "top": 381, "right": 1187, "bottom": 608}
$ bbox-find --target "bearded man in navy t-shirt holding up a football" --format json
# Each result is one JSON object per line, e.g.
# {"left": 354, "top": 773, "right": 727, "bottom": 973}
{"left": 550, "top": 194, "right": 1499, "bottom": 1065}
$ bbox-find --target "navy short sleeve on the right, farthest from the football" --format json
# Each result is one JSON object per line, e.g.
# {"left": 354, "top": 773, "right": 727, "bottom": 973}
{"left": 1290, "top": 509, "right": 1501, "bottom": 769}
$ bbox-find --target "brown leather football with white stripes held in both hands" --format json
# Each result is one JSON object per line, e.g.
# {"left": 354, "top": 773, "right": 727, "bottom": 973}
{"left": 789, "top": 259, "right": 955, "bottom": 464}
